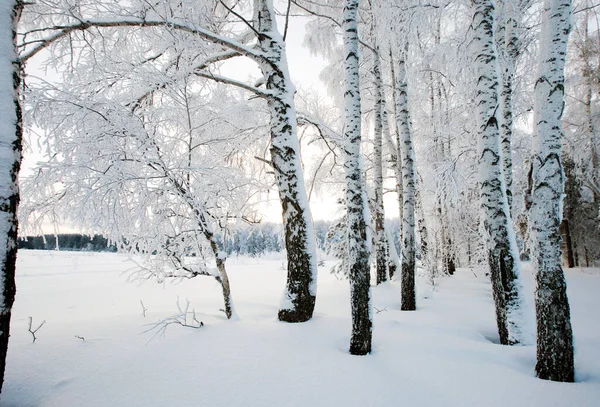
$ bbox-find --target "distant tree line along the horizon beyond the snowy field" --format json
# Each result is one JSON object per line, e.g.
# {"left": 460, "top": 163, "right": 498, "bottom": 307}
{"left": 18, "top": 219, "right": 399, "bottom": 257}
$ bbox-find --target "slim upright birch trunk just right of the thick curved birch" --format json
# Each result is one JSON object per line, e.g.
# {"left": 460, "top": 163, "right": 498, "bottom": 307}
{"left": 342, "top": 0, "right": 373, "bottom": 355}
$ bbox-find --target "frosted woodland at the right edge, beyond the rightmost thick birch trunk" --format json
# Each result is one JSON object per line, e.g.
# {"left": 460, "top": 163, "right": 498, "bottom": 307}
{"left": 561, "top": 0, "right": 600, "bottom": 267}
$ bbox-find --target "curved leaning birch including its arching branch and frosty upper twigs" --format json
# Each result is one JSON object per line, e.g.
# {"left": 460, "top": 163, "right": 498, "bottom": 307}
{"left": 21, "top": 0, "right": 317, "bottom": 322}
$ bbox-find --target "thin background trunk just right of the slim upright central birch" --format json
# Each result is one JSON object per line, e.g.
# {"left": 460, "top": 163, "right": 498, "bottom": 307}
{"left": 373, "top": 47, "right": 388, "bottom": 284}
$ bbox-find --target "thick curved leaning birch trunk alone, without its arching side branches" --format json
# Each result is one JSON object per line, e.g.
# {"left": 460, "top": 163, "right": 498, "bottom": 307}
{"left": 256, "top": 0, "right": 317, "bottom": 322}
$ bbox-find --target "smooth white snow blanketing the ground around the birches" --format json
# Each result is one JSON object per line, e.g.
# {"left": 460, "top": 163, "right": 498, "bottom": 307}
{"left": 0, "top": 250, "right": 600, "bottom": 407}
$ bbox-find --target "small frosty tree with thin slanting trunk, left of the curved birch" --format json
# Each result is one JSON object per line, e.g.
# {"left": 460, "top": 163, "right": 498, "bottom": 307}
{"left": 22, "top": 79, "right": 258, "bottom": 318}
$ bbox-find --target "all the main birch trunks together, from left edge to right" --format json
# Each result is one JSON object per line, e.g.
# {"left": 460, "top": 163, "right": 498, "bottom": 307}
{"left": 0, "top": 0, "right": 574, "bottom": 396}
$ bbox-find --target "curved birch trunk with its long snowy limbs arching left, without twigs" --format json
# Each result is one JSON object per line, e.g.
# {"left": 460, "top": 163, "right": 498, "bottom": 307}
{"left": 21, "top": 0, "right": 317, "bottom": 322}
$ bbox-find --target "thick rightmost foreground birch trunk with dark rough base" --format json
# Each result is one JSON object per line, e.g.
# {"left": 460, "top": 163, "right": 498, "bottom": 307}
{"left": 530, "top": 0, "right": 574, "bottom": 382}
